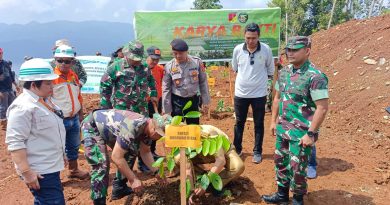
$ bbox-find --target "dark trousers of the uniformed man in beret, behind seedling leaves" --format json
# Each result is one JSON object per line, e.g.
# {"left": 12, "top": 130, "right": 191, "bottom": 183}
{"left": 171, "top": 94, "right": 199, "bottom": 125}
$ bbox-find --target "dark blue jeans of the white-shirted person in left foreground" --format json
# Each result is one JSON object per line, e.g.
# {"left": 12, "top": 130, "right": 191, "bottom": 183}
{"left": 30, "top": 172, "right": 65, "bottom": 205}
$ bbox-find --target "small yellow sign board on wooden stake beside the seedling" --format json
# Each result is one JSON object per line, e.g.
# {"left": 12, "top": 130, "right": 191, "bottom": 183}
{"left": 165, "top": 125, "right": 201, "bottom": 148}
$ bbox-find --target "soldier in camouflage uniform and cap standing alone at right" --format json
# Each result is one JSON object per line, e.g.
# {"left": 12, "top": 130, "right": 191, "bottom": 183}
{"left": 263, "top": 36, "right": 329, "bottom": 205}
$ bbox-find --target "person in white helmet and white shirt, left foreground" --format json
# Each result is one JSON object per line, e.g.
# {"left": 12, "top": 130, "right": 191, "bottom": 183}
{"left": 6, "top": 59, "right": 66, "bottom": 204}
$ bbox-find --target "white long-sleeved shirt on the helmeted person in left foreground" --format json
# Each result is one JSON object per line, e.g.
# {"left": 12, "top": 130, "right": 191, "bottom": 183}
{"left": 5, "top": 89, "right": 66, "bottom": 174}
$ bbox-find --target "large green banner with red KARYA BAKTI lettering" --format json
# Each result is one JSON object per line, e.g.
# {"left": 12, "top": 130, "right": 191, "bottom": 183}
{"left": 134, "top": 8, "right": 280, "bottom": 61}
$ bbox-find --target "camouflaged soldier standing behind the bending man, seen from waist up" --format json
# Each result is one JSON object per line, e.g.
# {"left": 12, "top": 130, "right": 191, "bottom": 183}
{"left": 100, "top": 41, "right": 158, "bottom": 116}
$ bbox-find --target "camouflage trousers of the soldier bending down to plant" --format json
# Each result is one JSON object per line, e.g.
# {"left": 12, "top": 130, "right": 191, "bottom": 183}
{"left": 81, "top": 113, "right": 135, "bottom": 200}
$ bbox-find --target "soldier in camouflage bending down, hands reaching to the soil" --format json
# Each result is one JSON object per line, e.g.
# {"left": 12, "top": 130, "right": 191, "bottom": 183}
{"left": 81, "top": 109, "right": 171, "bottom": 205}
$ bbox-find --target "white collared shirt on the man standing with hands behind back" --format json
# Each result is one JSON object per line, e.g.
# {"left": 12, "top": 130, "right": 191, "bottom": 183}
{"left": 232, "top": 43, "right": 275, "bottom": 98}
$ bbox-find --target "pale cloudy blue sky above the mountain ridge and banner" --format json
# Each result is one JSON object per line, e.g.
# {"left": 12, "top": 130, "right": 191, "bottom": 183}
{"left": 0, "top": 0, "right": 268, "bottom": 24}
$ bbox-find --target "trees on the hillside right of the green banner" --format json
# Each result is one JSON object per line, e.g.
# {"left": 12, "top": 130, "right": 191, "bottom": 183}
{"left": 268, "top": 0, "right": 386, "bottom": 41}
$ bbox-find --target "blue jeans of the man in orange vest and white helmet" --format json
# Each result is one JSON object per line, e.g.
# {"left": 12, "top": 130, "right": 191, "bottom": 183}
{"left": 64, "top": 115, "right": 80, "bottom": 161}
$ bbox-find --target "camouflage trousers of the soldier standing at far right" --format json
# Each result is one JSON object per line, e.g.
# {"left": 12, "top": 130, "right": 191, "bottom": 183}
{"left": 274, "top": 135, "right": 311, "bottom": 194}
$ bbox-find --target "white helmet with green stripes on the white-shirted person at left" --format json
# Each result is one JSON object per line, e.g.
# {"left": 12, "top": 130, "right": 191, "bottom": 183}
{"left": 19, "top": 58, "right": 59, "bottom": 81}
